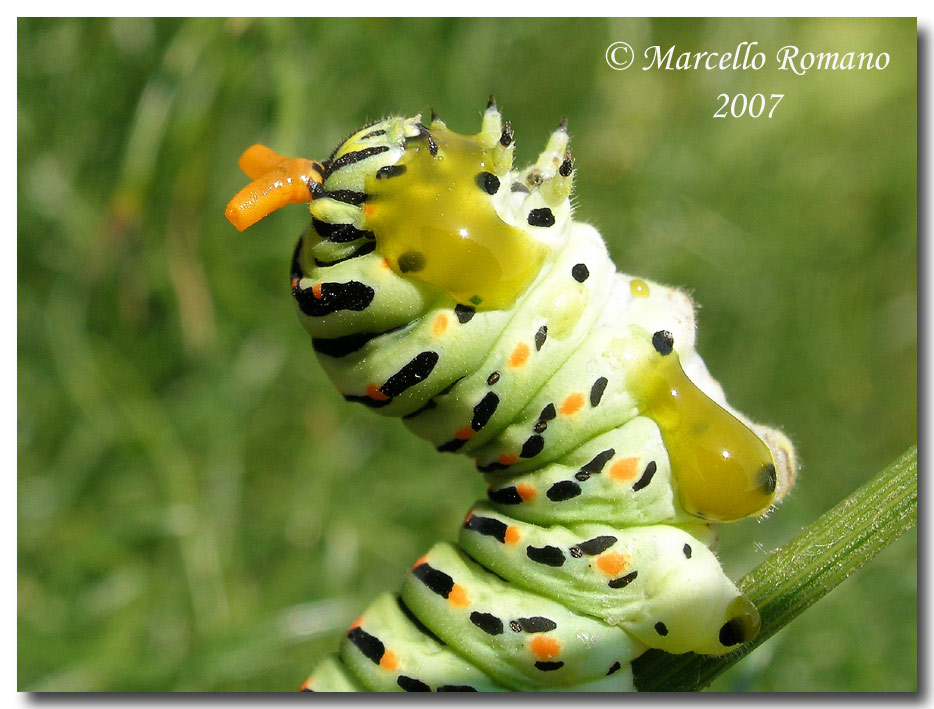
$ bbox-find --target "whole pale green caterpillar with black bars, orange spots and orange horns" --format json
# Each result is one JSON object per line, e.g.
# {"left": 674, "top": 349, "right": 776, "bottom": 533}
{"left": 226, "top": 97, "right": 795, "bottom": 692}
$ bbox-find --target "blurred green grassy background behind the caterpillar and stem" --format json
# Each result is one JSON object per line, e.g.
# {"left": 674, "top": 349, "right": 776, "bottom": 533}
{"left": 17, "top": 19, "right": 917, "bottom": 691}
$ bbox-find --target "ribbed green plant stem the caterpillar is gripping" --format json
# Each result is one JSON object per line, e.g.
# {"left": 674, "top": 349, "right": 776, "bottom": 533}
{"left": 633, "top": 446, "right": 918, "bottom": 692}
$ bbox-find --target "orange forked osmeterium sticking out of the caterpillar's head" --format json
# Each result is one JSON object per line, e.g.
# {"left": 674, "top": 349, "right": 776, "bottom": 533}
{"left": 224, "top": 144, "right": 324, "bottom": 231}
